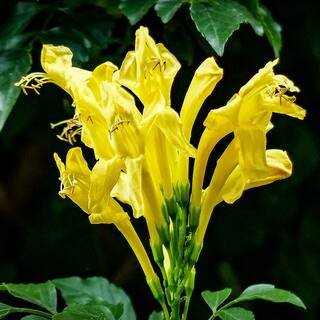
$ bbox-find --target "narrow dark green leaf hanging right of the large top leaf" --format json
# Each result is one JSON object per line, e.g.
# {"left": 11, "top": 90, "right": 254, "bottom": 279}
{"left": 259, "top": 7, "right": 282, "bottom": 57}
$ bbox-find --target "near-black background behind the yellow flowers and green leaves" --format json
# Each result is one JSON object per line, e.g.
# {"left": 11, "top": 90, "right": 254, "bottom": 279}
{"left": 0, "top": 0, "right": 320, "bottom": 320}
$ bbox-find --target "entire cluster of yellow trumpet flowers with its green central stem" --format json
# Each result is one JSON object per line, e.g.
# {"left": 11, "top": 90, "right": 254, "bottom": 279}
{"left": 17, "top": 27, "right": 305, "bottom": 319}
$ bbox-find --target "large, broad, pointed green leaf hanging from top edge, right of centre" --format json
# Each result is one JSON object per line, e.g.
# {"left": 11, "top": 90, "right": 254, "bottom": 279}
{"left": 190, "top": 0, "right": 263, "bottom": 56}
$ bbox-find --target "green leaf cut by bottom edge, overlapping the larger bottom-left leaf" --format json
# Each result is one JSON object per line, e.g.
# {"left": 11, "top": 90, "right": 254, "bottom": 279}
{"left": 52, "top": 304, "right": 116, "bottom": 320}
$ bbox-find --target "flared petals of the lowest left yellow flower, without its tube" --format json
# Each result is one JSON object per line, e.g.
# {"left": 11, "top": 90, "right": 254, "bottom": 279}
{"left": 54, "top": 147, "right": 129, "bottom": 223}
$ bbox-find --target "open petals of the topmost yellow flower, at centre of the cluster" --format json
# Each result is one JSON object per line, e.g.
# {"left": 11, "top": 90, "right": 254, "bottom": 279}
{"left": 119, "top": 27, "right": 180, "bottom": 116}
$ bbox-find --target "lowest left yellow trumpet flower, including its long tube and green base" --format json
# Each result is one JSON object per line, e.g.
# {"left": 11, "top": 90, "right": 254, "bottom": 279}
{"left": 54, "top": 147, "right": 161, "bottom": 296}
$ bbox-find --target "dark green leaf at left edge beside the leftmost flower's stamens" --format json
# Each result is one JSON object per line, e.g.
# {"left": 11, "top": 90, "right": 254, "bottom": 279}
{"left": 0, "top": 49, "right": 31, "bottom": 130}
